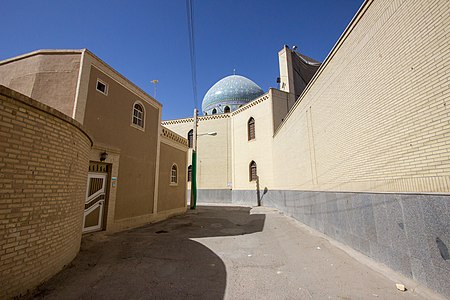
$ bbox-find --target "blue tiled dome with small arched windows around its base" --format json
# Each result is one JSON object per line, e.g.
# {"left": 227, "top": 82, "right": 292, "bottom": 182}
{"left": 202, "top": 75, "right": 264, "bottom": 115}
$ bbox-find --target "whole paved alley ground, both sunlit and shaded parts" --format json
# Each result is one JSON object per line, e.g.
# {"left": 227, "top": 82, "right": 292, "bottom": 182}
{"left": 25, "top": 206, "right": 440, "bottom": 299}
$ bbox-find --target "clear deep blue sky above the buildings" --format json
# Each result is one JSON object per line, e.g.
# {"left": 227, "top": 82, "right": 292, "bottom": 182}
{"left": 0, "top": 0, "right": 363, "bottom": 120}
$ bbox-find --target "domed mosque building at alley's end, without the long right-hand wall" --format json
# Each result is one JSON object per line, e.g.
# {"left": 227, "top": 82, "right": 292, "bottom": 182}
{"left": 162, "top": 45, "right": 320, "bottom": 204}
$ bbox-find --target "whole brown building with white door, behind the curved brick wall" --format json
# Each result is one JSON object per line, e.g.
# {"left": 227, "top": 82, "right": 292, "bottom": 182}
{"left": 0, "top": 49, "right": 187, "bottom": 232}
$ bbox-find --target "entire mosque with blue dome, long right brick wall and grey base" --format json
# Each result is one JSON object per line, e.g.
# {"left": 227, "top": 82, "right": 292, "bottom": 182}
{"left": 162, "top": 0, "right": 450, "bottom": 297}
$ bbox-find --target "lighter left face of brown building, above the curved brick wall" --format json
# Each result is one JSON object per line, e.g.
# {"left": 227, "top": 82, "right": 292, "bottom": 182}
{"left": 0, "top": 50, "right": 81, "bottom": 117}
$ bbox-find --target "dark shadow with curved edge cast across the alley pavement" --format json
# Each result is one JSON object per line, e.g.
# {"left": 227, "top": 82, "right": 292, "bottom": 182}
{"left": 28, "top": 206, "right": 265, "bottom": 299}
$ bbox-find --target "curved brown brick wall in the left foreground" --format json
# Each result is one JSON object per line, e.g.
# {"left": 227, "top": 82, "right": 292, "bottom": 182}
{"left": 0, "top": 86, "right": 92, "bottom": 299}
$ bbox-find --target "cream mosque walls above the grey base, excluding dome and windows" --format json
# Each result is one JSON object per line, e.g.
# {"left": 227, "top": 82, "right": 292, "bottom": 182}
{"left": 164, "top": 0, "right": 450, "bottom": 193}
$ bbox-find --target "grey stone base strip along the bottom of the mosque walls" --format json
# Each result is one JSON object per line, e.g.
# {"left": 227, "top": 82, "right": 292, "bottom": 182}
{"left": 198, "top": 190, "right": 450, "bottom": 298}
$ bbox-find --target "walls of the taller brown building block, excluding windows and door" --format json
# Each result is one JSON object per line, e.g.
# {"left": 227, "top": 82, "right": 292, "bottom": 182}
{"left": 0, "top": 49, "right": 188, "bottom": 231}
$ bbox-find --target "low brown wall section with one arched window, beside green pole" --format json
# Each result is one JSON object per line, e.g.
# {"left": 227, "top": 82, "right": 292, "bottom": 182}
{"left": 158, "top": 138, "right": 188, "bottom": 212}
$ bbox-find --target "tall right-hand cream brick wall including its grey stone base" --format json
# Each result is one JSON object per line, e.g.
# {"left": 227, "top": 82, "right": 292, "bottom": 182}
{"left": 268, "top": 0, "right": 450, "bottom": 298}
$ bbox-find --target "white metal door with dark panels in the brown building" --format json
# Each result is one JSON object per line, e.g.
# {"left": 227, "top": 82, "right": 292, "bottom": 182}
{"left": 83, "top": 173, "right": 107, "bottom": 233}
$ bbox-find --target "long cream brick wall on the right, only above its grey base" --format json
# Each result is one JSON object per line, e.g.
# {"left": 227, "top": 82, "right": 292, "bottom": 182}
{"left": 273, "top": 0, "right": 450, "bottom": 193}
